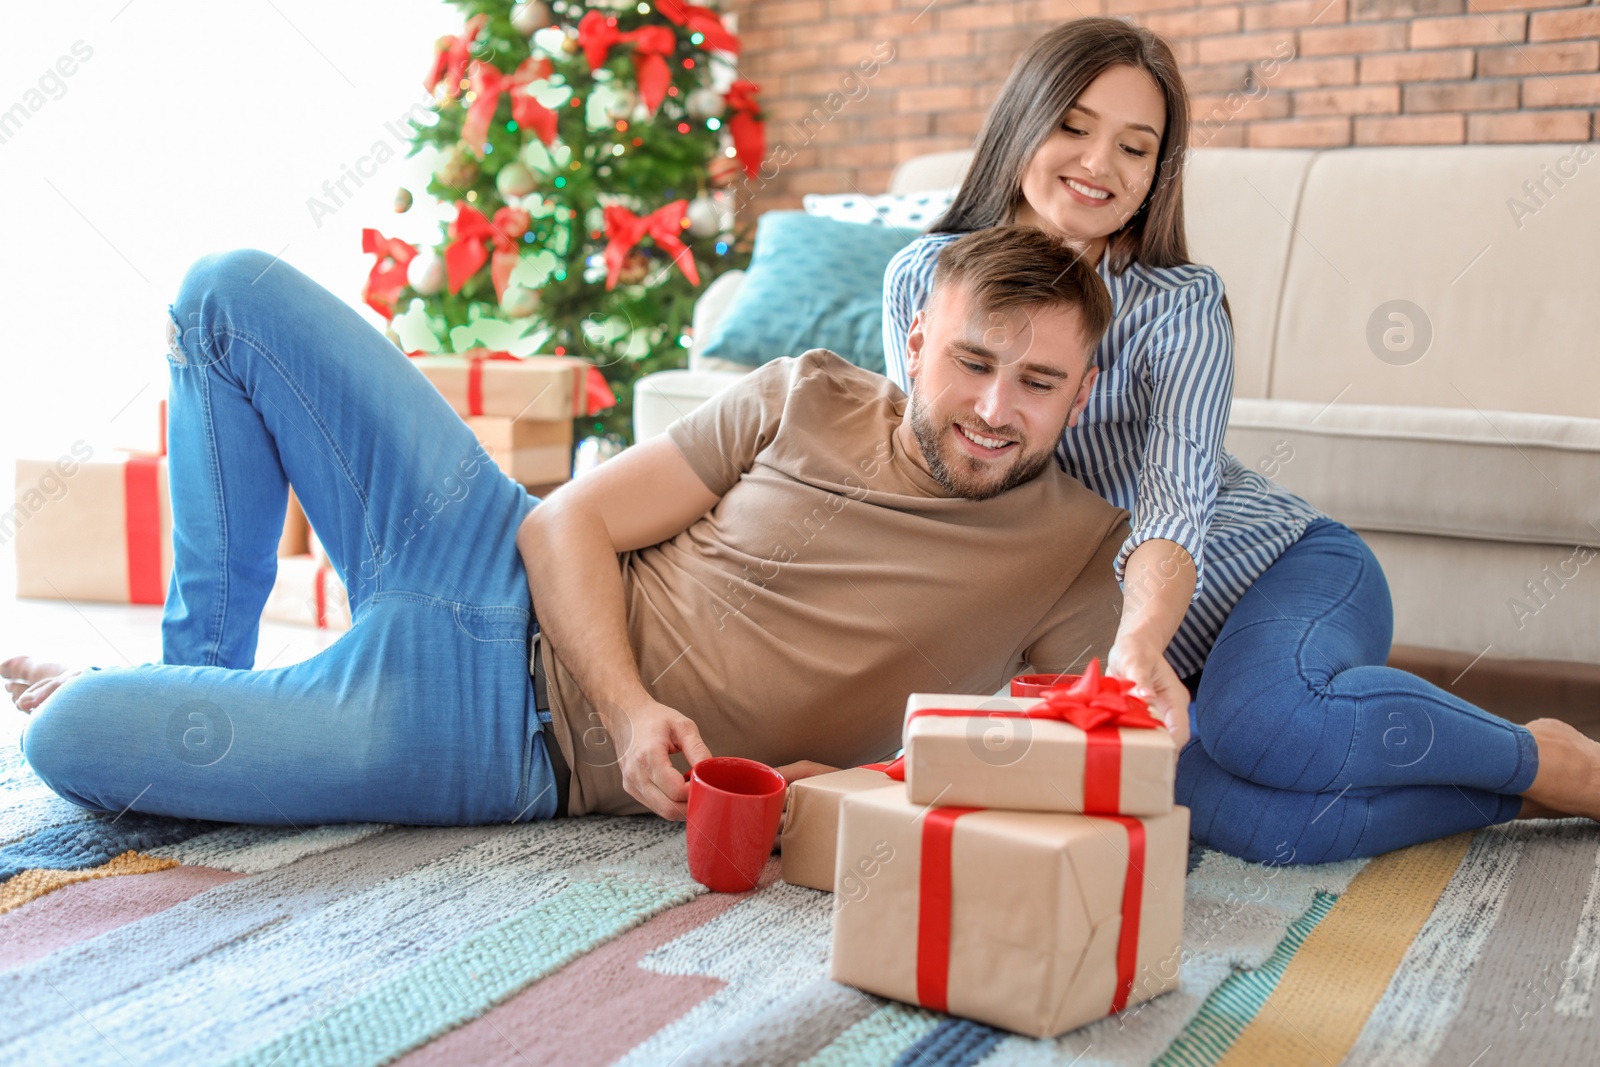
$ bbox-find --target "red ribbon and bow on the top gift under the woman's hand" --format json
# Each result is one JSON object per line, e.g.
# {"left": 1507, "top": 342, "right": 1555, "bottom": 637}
{"left": 883, "top": 659, "right": 1162, "bottom": 814}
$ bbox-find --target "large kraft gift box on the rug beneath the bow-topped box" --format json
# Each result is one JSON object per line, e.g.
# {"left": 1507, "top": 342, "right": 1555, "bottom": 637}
{"left": 830, "top": 789, "right": 1189, "bottom": 1038}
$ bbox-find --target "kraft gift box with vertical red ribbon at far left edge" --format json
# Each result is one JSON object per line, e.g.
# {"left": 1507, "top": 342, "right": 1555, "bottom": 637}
{"left": 12, "top": 446, "right": 173, "bottom": 605}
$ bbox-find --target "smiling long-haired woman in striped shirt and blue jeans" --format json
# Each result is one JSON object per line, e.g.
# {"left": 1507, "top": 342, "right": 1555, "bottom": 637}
{"left": 883, "top": 18, "right": 1600, "bottom": 864}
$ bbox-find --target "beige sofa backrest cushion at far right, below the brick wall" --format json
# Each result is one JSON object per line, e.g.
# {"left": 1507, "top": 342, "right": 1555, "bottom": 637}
{"left": 1260, "top": 144, "right": 1600, "bottom": 418}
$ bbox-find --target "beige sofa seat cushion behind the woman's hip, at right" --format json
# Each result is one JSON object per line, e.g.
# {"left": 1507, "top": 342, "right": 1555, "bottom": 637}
{"left": 1227, "top": 400, "right": 1600, "bottom": 550}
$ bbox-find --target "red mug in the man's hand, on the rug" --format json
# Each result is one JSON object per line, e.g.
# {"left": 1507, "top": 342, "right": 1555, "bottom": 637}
{"left": 688, "top": 755, "right": 787, "bottom": 893}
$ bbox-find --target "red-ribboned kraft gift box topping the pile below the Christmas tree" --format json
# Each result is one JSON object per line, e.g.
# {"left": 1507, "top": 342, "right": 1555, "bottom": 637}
{"left": 411, "top": 350, "right": 592, "bottom": 422}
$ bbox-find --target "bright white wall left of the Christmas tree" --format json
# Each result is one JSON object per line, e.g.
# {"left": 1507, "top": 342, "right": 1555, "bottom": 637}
{"left": 0, "top": 0, "right": 461, "bottom": 467}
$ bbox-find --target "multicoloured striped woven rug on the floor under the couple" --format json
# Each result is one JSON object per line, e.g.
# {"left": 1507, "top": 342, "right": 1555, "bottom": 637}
{"left": 0, "top": 745, "right": 1600, "bottom": 1067}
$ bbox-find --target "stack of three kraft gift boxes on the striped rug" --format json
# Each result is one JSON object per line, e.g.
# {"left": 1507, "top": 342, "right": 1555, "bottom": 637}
{"left": 781, "top": 664, "right": 1189, "bottom": 1038}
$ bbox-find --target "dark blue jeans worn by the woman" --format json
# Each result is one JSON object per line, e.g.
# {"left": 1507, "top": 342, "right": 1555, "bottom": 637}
{"left": 1178, "top": 520, "right": 1539, "bottom": 864}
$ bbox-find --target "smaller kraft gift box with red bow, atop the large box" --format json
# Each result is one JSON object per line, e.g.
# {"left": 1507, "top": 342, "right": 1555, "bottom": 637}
{"left": 896, "top": 662, "right": 1178, "bottom": 816}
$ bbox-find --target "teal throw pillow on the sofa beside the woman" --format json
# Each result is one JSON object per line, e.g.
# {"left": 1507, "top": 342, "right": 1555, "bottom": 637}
{"left": 701, "top": 211, "right": 922, "bottom": 374}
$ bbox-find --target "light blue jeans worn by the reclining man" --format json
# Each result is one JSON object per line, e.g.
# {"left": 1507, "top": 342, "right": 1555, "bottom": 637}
{"left": 22, "top": 250, "right": 557, "bottom": 825}
